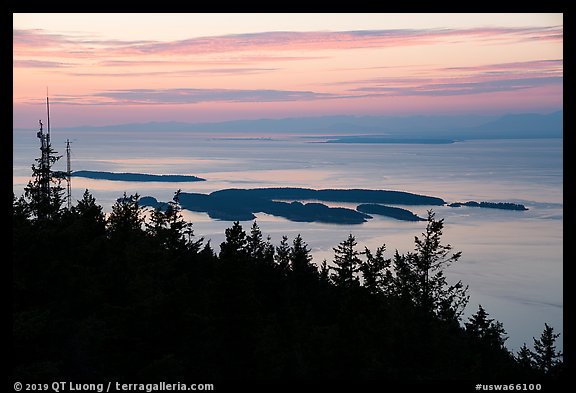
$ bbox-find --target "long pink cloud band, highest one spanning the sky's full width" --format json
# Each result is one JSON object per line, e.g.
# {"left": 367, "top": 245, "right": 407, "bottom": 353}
{"left": 13, "top": 26, "right": 563, "bottom": 56}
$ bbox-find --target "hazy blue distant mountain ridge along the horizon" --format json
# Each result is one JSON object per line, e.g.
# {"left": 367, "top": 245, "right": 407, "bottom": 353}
{"left": 19, "top": 110, "right": 564, "bottom": 140}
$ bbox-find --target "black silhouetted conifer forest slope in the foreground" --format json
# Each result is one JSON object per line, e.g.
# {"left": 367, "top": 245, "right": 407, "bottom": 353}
{"left": 12, "top": 149, "right": 563, "bottom": 381}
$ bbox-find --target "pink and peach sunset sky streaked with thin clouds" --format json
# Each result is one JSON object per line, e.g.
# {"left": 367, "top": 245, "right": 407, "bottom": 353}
{"left": 13, "top": 14, "right": 563, "bottom": 128}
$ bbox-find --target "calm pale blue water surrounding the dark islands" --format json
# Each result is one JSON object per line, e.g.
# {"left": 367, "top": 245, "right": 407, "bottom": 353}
{"left": 13, "top": 130, "right": 563, "bottom": 351}
